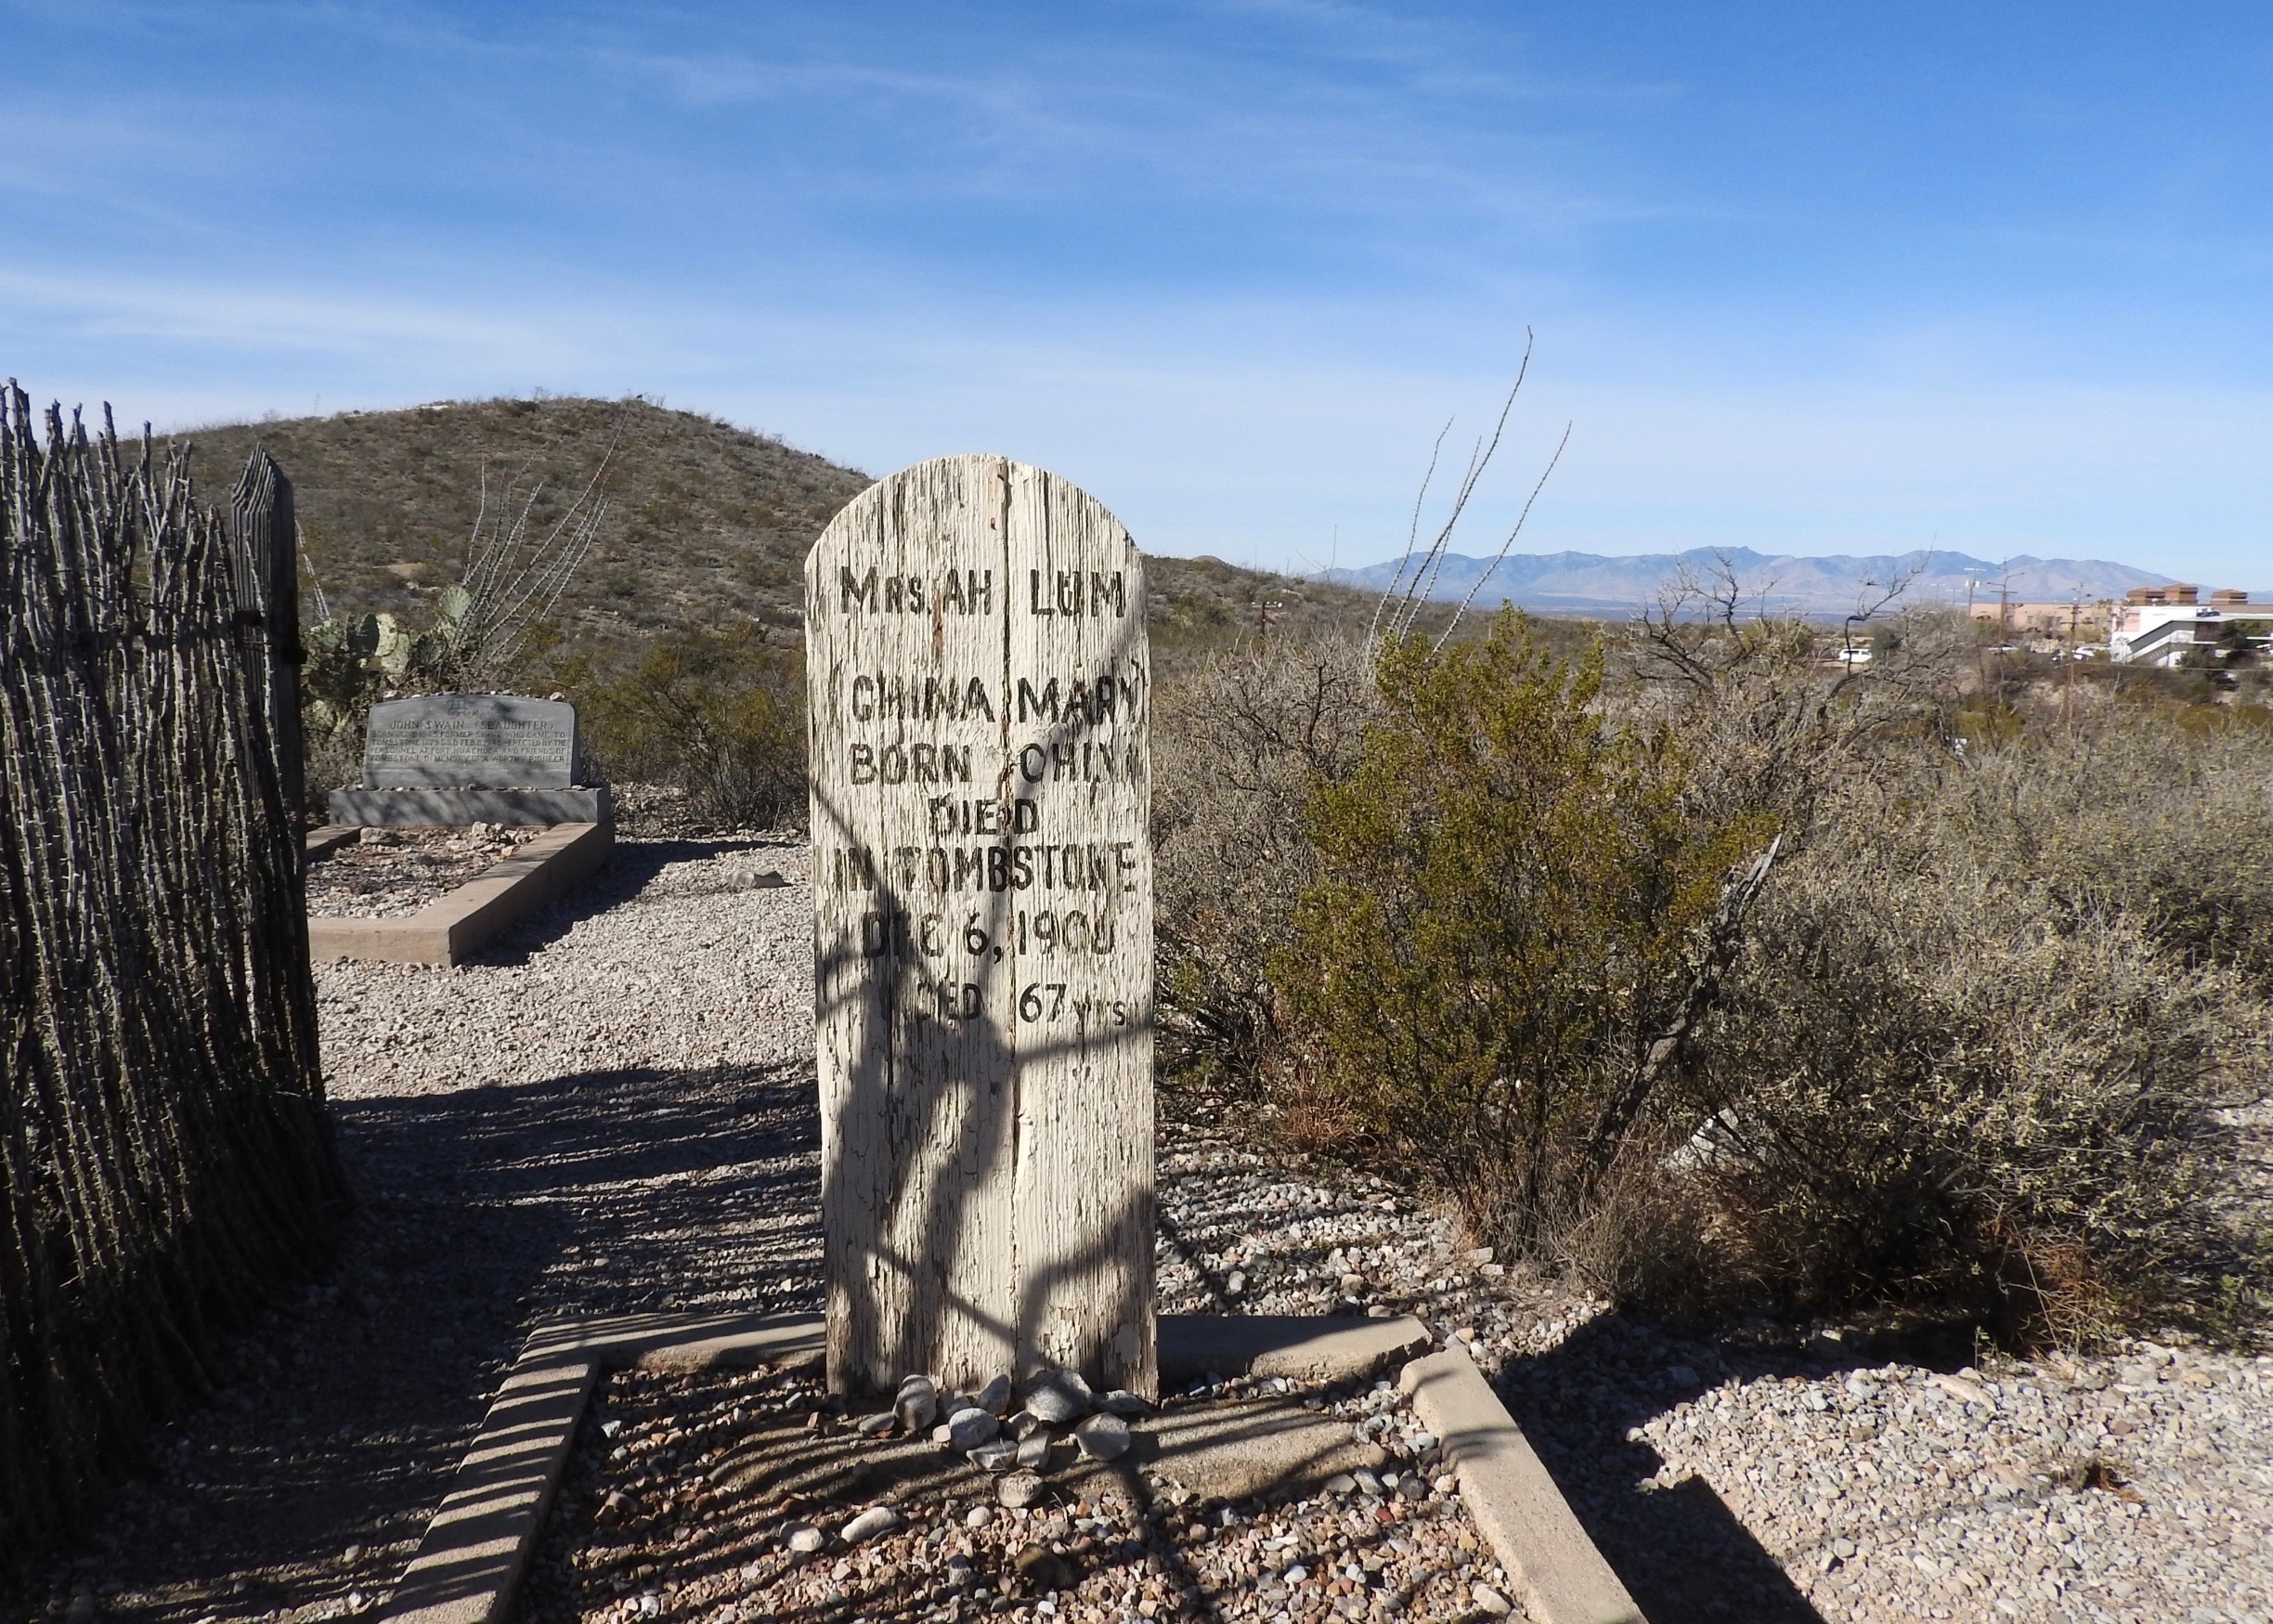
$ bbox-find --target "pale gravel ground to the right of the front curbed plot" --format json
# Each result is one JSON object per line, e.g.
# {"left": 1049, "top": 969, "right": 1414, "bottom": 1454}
{"left": 1159, "top": 1128, "right": 2273, "bottom": 1624}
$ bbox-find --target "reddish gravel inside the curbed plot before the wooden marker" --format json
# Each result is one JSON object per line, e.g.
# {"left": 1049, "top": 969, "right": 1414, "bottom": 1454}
{"left": 516, "top": 1371, "right": 1521, "bottom": 1624}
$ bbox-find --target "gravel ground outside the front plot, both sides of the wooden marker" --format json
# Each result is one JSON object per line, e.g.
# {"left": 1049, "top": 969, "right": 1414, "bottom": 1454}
{"left": 11, "top": 839, "right": 2273, "bottom": 1624}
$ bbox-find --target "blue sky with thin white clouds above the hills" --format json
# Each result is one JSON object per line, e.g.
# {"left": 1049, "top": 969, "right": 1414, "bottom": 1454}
{"left": 0, "top": 0, "right": 2273, "bottom": 589}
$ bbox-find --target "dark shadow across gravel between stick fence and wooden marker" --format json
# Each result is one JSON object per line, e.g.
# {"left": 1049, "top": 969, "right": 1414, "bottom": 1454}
{"left": 32, "top": 1067, "right": 821, "bottom": 1624}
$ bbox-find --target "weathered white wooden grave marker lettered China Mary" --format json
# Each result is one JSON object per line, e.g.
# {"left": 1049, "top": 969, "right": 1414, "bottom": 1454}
{"left": 805, "top": 457, "right": 1157, "bottom": 1397}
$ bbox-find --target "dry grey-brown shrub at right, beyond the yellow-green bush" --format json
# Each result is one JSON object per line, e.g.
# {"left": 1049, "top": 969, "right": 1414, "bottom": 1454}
{"left": 1655, "top": 719, "right": 2273, "bottom": 1340}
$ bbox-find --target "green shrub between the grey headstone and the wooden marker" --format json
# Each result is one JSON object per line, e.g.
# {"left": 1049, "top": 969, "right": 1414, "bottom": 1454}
{"left": 564, "top": 626, "right": 805, "bottom": 828}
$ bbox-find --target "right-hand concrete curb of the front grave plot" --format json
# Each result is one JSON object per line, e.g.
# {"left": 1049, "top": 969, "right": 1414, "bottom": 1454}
{"left": 1398, "top": 1349, "right": 1648, "bottom": 1624}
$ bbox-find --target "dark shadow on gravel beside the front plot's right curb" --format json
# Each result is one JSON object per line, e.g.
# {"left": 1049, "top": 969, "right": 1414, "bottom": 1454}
{"left": 1496, "top": 1315, "right": 1859, "bottom": 1624}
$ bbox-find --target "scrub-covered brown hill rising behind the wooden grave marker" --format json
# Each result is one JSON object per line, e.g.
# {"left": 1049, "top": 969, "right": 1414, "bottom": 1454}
{"left": 175, "top": 396, "right": 1375, "bottom": 662}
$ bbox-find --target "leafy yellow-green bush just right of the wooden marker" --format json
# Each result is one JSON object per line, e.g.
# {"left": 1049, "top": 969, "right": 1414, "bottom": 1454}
{"left": 1275, "top": 612, "right": 1773, "bottom": 1246}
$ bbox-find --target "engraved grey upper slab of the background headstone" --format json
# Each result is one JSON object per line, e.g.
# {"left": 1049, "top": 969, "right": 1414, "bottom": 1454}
{"left": 364, "top": 694, "right": 578, "bottom": 789}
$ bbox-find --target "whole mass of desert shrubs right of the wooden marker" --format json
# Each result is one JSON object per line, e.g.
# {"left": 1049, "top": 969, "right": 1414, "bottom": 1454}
{"left": 1155, "top": 585, "right": 2273, "bottom": 1342}
